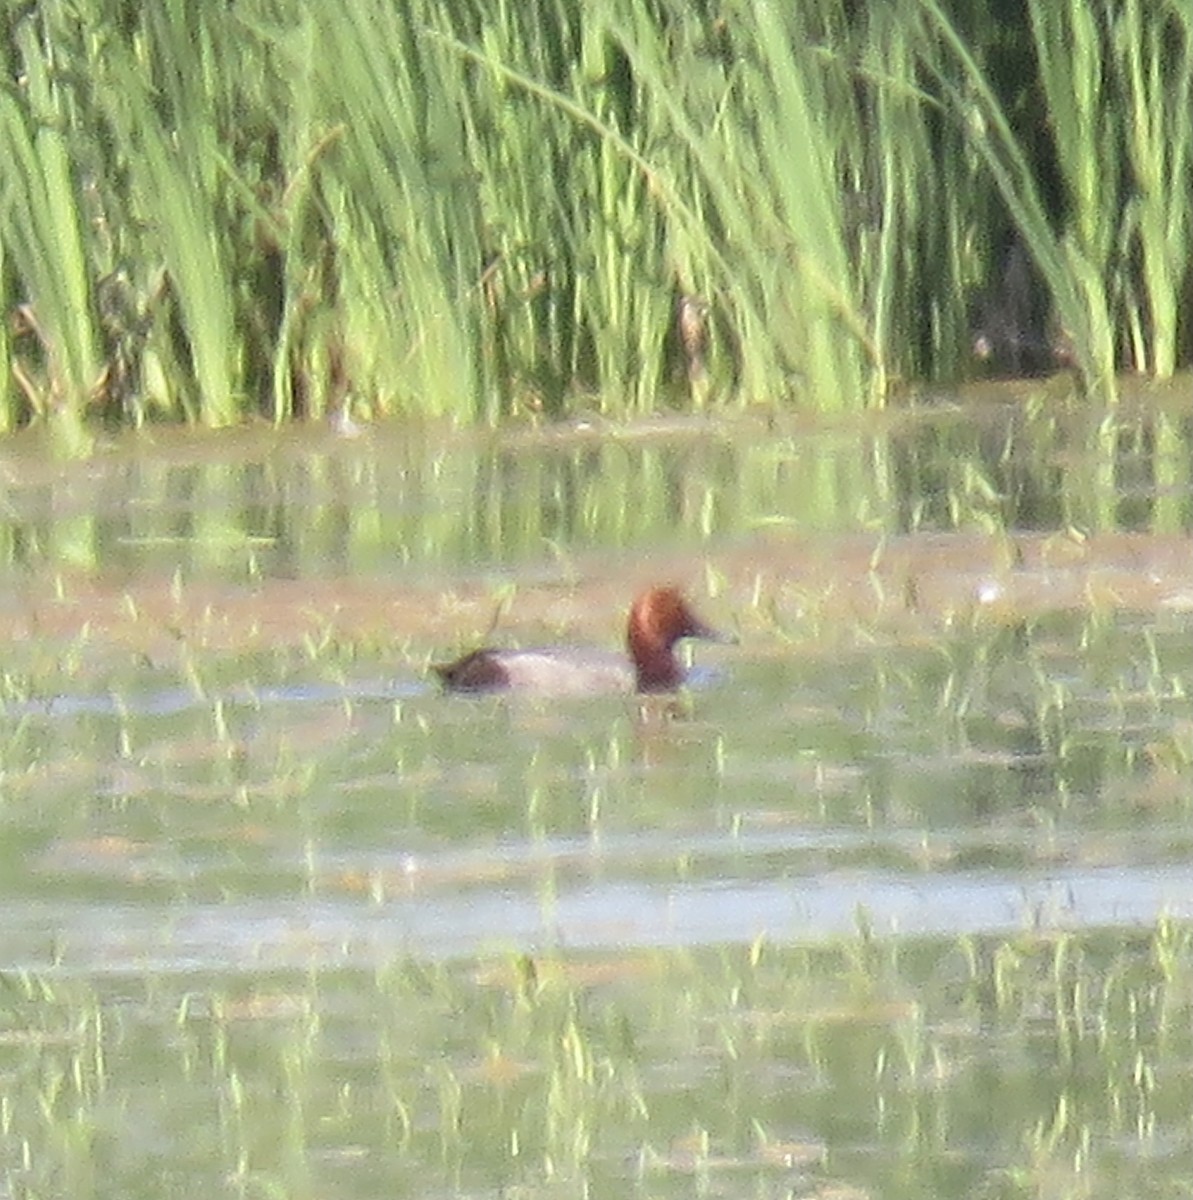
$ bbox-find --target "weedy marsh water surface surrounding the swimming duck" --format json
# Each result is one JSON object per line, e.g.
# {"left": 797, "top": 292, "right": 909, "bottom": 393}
{"left": 0, "top": 397, "right": 1193, "bottom": 1198}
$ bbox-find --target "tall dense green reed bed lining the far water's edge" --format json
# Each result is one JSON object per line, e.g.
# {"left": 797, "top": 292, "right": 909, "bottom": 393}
{"left": 0, "top": 0, "right": 1193, "bottom": 439}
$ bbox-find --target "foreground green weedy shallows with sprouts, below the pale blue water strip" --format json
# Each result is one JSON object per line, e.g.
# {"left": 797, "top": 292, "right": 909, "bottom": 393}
{"left": 9, "top": 920, "right": 1193, "bottom": 1200}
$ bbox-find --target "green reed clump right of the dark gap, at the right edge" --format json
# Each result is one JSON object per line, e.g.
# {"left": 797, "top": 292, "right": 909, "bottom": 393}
{"left": 922, "top": 0, "right": 1193, "bottom": 401}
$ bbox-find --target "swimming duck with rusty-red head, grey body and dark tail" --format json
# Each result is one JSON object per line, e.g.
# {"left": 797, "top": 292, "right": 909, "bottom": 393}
{"left": 432, "top": 587, "right": 726, "bottom": 695}
